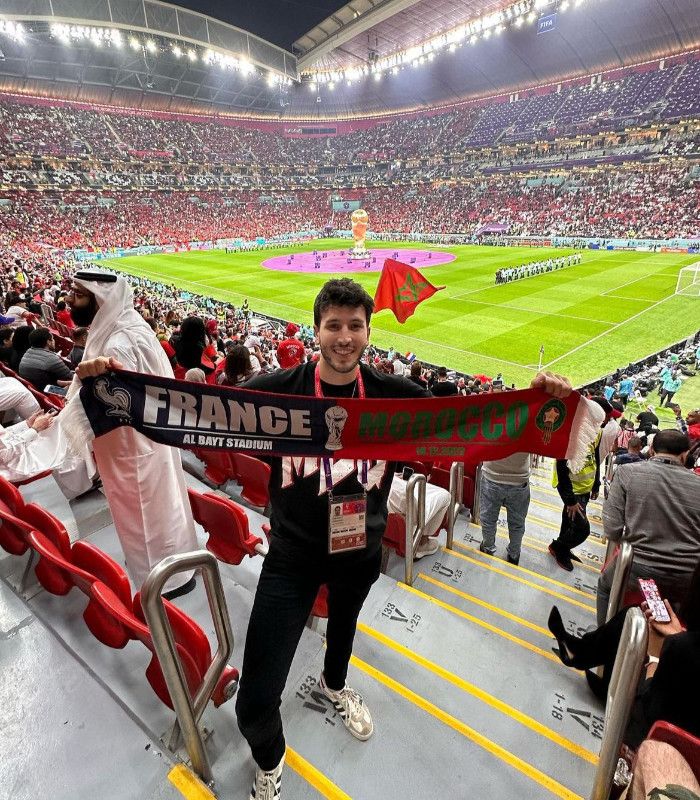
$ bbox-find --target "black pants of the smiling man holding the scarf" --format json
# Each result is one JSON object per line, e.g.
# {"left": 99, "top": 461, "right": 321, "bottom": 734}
{"left": 236, "top": 537, "right": 381, "bottom": 770}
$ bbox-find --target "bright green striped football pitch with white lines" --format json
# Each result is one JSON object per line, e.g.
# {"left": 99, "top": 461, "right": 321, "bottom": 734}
{"left": 110, "top": 239, "right": 700, "bottom": 386}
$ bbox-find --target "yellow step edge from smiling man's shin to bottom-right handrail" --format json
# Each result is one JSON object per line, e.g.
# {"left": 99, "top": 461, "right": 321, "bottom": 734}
{"left": 357, "top": 622, "right": 598, "bottom": 764}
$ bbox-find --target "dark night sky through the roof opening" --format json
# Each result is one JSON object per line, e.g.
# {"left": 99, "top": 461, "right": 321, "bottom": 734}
{"left": 170, "top": 0, "right": 347, "bottom": 50}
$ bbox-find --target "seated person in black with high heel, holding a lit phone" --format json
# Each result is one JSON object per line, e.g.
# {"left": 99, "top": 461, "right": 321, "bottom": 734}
{"left": 548, "top": 551, "right": 700, "bottom": 749}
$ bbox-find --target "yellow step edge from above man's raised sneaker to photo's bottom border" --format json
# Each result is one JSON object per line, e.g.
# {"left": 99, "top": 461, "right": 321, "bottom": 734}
{"left": 350, "top": 656, "right": 583, "bottom": 800}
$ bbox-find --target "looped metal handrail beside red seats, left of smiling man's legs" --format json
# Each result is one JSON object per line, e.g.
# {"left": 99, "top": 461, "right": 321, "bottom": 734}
{"left": 141, "top": 550, "right": 233, "bottom": 784}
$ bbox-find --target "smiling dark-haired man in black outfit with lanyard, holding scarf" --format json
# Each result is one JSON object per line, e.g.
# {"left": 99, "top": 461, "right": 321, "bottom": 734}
{"left": 236, "top": 278, "right": 571, "bottom": 800}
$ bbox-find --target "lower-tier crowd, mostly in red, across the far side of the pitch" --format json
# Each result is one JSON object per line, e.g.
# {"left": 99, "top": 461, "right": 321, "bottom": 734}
{"left": 0, "top": 165, "right": 700, "bottom": 255}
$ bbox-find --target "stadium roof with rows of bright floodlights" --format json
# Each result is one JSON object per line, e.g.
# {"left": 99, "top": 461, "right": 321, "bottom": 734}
{"left": 0, "top": 0, "right": 700, "bottom": 119}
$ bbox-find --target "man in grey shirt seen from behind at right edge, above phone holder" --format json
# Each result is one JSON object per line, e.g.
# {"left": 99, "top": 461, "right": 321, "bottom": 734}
{"left": 596, "top": 430, "right": 700, "bottom": 625}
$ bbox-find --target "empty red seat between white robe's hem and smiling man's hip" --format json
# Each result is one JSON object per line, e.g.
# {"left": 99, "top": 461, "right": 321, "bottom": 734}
{"left": 187, "top": 489, "right": 263, "bottom": 564}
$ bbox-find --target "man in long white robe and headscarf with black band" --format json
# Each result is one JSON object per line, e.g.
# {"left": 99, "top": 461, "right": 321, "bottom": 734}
{"left": 58, "top": 269, "right": 197, "bottom": 599}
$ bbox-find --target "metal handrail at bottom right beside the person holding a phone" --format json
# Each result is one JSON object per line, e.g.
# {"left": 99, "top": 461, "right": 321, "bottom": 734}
{"left": 591, "top": 608, "right": 649, "bottom": 800}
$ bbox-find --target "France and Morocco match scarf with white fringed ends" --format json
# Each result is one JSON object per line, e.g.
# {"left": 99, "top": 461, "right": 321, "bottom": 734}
{"left": 63, "top": 370, "right": 604, "bottom": 471}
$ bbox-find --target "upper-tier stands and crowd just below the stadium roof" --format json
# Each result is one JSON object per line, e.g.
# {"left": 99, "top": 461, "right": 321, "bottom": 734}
{"left": 0, "top": 60, "right": 700, "bottom": 165}
